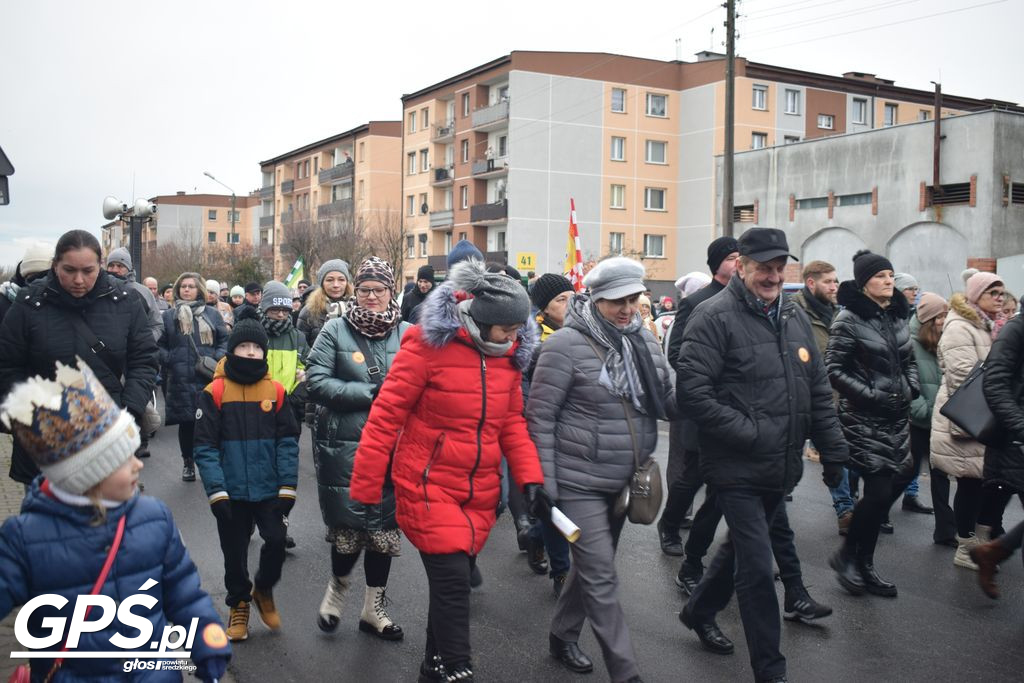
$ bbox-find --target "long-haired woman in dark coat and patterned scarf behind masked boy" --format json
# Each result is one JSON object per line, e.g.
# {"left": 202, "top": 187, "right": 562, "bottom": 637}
{"left": 160, "top": 272, "right": 227, "bottom": 481}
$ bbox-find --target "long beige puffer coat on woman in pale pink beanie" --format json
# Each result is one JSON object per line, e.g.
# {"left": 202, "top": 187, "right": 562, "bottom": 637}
{"left": 931, "top": 293, "right": 992, "bottom": 479}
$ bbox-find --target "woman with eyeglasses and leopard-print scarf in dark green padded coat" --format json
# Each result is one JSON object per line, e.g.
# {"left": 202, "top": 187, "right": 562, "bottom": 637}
{"left": 306, "top": 256, "right": 412, "bottom": 640}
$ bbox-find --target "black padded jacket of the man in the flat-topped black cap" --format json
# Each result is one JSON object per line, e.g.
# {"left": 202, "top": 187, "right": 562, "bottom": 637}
{"left": 676, "top": 275, "right": 847, "bottom": 492}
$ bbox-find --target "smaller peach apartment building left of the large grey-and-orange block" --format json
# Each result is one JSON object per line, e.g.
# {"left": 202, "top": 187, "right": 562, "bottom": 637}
{"left": 256, "top": 121, "right": 401, "bottom": 278}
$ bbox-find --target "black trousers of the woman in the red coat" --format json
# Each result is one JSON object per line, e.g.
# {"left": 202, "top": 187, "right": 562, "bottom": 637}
{"left": 420, "top": 552, "right": 472, "bottom": 669}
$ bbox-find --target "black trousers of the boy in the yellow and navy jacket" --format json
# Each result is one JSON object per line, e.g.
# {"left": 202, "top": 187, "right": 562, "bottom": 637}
{"left": 217, "top": 498, "right": 285, "bottom": 607}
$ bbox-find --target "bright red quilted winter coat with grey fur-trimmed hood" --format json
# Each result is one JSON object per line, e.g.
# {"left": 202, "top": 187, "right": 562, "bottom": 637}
{"left": 351, "top": 284, "right": 544, "bottom": 555}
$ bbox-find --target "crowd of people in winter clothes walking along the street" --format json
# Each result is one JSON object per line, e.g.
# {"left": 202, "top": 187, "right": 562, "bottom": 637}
{"left": 0, "top": 227, "right": 1024, "bottom": 683}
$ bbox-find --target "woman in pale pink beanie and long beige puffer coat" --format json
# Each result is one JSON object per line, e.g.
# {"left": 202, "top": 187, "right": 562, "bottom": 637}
{"left": 931, "top": 272, "right": 1007, "bottom": 570}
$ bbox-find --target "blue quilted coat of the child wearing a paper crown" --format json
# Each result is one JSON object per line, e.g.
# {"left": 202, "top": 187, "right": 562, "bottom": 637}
{"left": 0, "top": 483, "right": 231, "bottom": 682}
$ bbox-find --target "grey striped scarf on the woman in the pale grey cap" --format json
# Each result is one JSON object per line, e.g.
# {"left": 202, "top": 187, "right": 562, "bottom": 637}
{"left": 569, "top": 294, "right": 668, "bottom": 420}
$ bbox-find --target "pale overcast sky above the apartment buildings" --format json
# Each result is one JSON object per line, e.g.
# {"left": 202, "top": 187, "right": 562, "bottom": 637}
{"left": 0, "top": 0, "right": 1024, "bottom": 265}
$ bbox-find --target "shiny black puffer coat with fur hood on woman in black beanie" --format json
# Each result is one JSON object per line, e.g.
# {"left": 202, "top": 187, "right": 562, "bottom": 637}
{"left": 825, "top": 280, "right": 921, "bottom": 474}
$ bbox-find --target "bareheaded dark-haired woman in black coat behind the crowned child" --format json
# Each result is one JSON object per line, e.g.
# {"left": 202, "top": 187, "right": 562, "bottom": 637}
{"left": 0, "top": 230, "right": 158, "bottom": 484}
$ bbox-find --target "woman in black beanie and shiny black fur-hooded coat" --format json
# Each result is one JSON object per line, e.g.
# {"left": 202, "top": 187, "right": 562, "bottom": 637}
{"left": 825, "top": 250, "right": 920, "bottom": 597}
